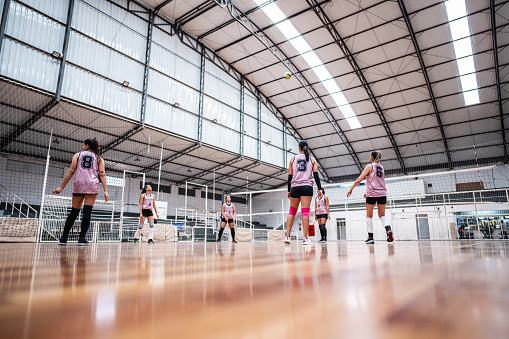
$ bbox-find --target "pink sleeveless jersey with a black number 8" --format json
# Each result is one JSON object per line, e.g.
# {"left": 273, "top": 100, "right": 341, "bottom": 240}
{"left": 72, "top": 151, "right": 99, "bottom": 194}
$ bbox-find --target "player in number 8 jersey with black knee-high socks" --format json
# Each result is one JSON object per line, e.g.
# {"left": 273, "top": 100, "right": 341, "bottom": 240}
{"left": 53, "top": 138, "right": 110, "bottom": 246}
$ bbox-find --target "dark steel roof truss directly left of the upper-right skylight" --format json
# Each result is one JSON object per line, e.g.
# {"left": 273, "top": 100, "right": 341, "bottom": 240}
{"left": 398, "top": 0, "right": 452, "bottom": 170}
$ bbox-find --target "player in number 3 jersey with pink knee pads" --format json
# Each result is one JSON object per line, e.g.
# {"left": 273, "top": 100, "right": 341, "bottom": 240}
{"left": 285, "top": 140, "right": 322, "bottom": 245}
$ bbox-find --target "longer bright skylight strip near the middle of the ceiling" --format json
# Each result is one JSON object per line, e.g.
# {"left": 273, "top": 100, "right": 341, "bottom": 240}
{"left": 254, "top": 0, "right": 360, "bottom": 129}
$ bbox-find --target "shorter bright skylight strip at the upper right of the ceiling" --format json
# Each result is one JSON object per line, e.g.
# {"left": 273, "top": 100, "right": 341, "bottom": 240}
{"left": 445, "top": 0, "right": 480, "bottom": 106}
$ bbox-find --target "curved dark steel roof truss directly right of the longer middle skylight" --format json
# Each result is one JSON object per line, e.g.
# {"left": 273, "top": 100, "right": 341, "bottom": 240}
{"left": 306, "top": 0, "right": 407, "bottom": 174}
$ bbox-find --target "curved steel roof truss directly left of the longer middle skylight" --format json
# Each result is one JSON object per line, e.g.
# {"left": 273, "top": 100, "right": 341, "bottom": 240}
{"left": 214, "top": 0, "right": 363, "bottom": 175}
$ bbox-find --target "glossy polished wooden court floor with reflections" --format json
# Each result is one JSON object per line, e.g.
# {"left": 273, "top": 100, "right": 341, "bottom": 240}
{"left": 0, "top": 241, "right": 509, "bottom": 339}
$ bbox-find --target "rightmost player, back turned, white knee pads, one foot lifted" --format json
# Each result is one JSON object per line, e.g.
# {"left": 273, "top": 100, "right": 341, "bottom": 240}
{"left": 346, "top": 151, "right": 394, "bottom": 244}
